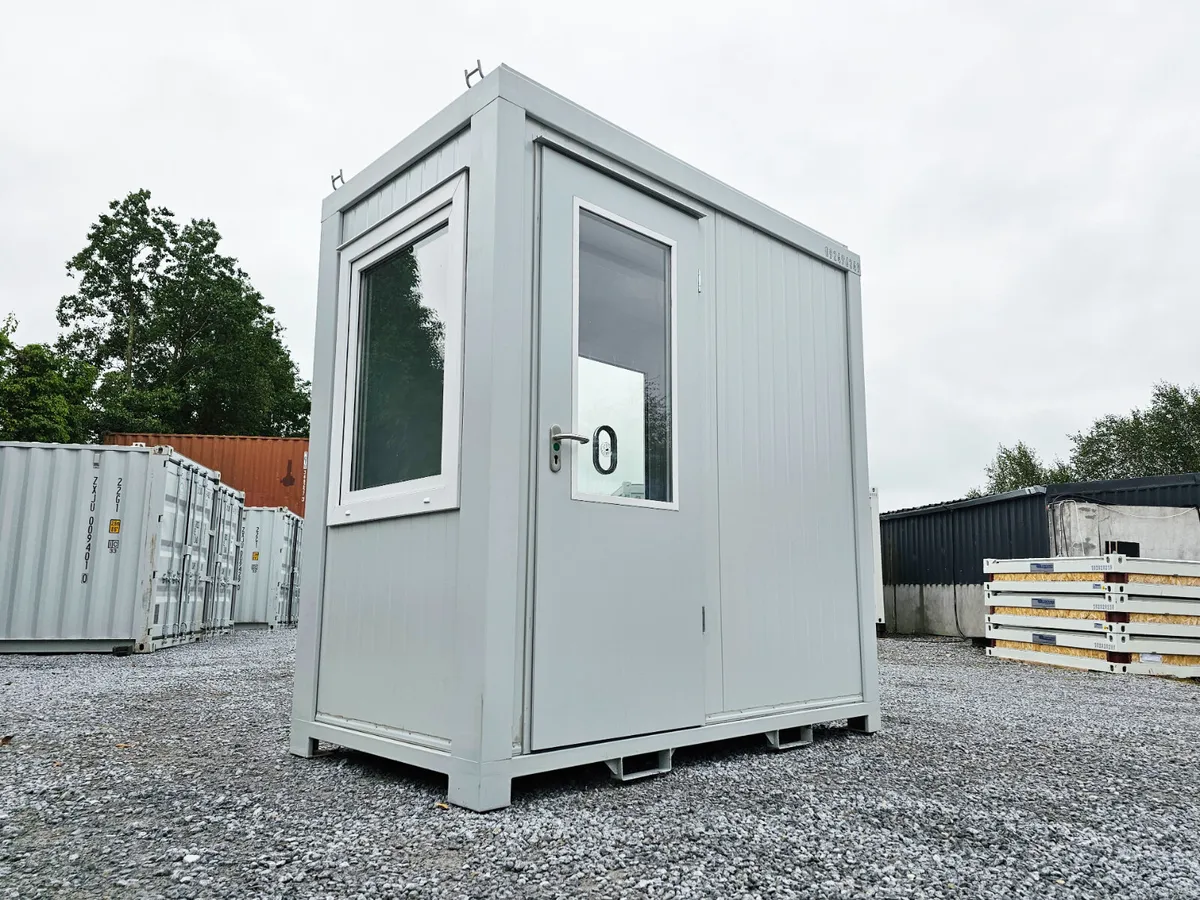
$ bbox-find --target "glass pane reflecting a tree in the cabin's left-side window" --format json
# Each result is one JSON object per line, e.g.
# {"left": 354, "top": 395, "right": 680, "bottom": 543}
{"left": 350, "top": 228, "right": 450, "bottom": 491}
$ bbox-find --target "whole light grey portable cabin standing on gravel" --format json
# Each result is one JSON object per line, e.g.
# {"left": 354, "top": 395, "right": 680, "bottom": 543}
{"left": 292, "top": 67, "right": 880, "bottom": 810}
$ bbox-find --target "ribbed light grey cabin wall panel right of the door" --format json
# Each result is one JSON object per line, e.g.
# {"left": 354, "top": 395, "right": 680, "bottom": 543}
{"left": 715, "top": 216, "right": 869, "bottom": 710}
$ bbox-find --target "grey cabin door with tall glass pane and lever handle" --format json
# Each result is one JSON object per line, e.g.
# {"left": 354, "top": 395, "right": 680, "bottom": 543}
{"left": 530, "top": 149, "right": 706, "bottom": 750}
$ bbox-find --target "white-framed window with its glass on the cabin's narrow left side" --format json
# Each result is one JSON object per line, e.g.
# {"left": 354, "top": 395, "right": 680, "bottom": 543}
{"left": 330, "top": 175, "right": 466, "bottom": 524}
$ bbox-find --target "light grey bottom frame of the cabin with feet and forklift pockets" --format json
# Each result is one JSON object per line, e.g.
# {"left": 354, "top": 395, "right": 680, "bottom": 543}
{"left": 290, "top": 702, "right": 880, "bottom": 812}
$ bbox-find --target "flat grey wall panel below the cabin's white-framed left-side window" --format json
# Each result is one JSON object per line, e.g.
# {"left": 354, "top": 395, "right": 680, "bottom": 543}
{"left": 317, "top": 512, "right": 458, "bottom": 738}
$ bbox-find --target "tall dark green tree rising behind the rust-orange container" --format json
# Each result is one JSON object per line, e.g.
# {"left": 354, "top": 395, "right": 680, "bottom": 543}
{"left": 58, "top": 191, "right": 308, "bottom": 436}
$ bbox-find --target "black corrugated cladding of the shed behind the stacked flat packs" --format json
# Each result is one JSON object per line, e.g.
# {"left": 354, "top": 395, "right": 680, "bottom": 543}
{"left": 880, "top": 473, "right": 1200, "bottom": 584}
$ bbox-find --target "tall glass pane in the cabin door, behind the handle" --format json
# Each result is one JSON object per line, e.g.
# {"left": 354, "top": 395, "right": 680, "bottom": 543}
{"left": 571, "top": 209, "right": 674, "bottom": 503}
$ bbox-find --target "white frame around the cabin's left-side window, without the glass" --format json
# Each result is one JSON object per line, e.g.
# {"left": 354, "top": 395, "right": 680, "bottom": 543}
{"left": 326, "top": 172, "right": 467, "bottom": 526}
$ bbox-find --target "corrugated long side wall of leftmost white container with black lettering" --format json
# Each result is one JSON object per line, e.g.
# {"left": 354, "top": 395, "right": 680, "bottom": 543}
{"left": 0, "top": 445, "right": 161, "bottom": 641}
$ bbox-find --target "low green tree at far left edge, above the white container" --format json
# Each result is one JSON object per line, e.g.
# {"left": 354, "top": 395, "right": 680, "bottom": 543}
{"left": 0, "top": 316, "right": 96, "bottom": 443}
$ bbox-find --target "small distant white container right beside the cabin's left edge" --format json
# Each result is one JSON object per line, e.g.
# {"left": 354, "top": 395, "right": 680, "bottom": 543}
{"left": 234, "top": 506, "right": 302, "bottom": 628}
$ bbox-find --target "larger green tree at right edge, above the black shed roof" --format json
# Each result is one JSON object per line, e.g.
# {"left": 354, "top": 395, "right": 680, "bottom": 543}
{"left": 1070, "top": 383, "right": 1200, "bottom": 480}
